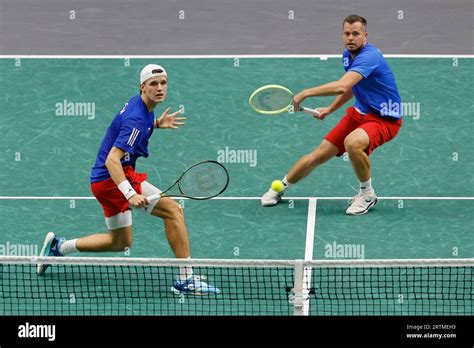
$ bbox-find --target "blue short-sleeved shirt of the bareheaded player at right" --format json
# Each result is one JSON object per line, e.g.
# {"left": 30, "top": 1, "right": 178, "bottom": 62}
{"left": 342, "top": 44, "right": 402, "bottom": 118}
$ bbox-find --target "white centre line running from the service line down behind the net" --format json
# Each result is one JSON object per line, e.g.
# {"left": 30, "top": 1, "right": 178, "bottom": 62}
{"left": 303, "top": 198, "right": 318, "bottom": 315}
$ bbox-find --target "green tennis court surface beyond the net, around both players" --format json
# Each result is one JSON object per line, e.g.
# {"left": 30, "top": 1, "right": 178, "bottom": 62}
{"left": 0, "top": 57, "right": 474, "bottom": 314}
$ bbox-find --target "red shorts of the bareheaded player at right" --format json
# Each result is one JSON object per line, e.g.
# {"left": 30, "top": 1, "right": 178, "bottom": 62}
{"left": 324, "top": 106, "right": 402, "bottom": 156}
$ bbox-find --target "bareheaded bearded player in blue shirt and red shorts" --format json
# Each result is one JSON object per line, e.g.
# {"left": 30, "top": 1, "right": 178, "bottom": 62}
{"left": 261, "top": 15, "right": 402, "bottom": 215}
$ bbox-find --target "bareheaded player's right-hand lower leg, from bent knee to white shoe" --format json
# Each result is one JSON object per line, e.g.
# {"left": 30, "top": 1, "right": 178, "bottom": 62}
{"left": 344, "top": 128, "right": 377, "bottom": 215}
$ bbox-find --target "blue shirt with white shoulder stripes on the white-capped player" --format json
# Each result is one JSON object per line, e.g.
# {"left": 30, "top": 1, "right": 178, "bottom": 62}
{"left": 90, "top": 95, "right": 155, "bottom": 183}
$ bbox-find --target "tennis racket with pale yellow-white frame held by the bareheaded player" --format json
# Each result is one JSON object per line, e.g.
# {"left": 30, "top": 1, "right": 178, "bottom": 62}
{"left": 249, "top": 85, "right": 319, "bottom": 116}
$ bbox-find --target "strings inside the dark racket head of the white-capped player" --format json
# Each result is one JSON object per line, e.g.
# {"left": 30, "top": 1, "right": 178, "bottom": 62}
{"left": 179, "top": 162, "right": 229, "bottom": 198}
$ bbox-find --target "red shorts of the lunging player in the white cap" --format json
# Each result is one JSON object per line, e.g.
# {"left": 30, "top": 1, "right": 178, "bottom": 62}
{"left": 91, "top": 166, "right": 148, "bottom": 217}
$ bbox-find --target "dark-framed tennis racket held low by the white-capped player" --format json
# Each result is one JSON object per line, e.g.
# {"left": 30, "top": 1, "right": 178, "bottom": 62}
{"left": 147, "top": 160, "right": 229, "bottom": 201}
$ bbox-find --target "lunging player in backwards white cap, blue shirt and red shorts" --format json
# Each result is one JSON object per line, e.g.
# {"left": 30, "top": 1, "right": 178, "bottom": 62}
{"left": 37, "top": 64, "right": 220, "bottom": 295}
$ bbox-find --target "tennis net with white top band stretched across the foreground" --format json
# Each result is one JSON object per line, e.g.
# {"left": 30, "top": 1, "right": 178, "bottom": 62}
{"left": 0, "top": 256, "right": 474, "bottom": 316}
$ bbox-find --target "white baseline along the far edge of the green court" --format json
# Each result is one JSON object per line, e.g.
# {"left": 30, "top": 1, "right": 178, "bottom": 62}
{"left": 0, "top": 54, "right": 474, "bottom": 60}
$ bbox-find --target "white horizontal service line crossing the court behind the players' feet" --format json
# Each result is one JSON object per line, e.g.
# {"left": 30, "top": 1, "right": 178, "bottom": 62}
{"left": 0, "top": 196, "right": 474, "bottom": 201}
